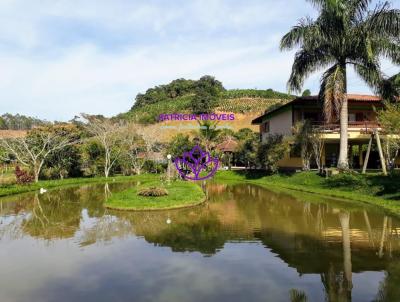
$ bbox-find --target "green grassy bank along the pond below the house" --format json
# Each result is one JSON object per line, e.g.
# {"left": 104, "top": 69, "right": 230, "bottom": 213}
{"left": 215, "top": 171, "right": 400, "bottom": 215}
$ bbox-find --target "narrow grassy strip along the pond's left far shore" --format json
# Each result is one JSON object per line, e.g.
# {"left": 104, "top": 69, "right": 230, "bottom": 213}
{"left": 0, "top": 174, "right": 159, "bottom": 197}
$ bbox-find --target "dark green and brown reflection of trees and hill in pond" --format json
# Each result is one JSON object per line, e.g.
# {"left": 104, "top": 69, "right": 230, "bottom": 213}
{"left": 0, "top": 183, "right": 400, "bottom": 301}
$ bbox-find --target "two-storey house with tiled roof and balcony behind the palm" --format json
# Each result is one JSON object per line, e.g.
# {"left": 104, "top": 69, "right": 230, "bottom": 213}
{"left": 252, "top": 94, "right": 400, "bottom": 169}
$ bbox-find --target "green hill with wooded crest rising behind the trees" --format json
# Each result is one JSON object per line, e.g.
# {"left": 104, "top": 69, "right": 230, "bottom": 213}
{"left": 118, "top": 76, "right": 295, "bottom": 124}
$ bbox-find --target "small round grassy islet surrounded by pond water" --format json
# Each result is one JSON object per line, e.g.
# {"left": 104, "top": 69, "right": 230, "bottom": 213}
{"left": 105, "top": 181, "right": 205, "bottom": 211}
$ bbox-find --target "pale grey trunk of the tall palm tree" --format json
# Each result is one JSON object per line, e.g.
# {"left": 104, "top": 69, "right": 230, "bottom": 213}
{"left": 338, "top": 93, "right": 349, "bottom": 170}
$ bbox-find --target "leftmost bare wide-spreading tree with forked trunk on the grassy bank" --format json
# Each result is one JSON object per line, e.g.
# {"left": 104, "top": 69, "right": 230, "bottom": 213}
{"left": 0, "top": 125, "right": 79, "bottom": 182}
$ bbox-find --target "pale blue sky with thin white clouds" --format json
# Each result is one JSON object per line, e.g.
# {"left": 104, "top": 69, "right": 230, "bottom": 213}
{"left": 0, "top": 0, "right": 399, "bottom": 121}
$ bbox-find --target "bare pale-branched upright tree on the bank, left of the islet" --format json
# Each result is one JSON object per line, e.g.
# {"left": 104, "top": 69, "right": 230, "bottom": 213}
{"left": 82, "top": 114, "right": 123, "bottom": 177}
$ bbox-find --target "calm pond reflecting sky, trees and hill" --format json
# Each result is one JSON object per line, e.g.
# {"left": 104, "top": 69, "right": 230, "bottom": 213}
{"left": 0, "top": 183, "right": 400, "bottom": 302}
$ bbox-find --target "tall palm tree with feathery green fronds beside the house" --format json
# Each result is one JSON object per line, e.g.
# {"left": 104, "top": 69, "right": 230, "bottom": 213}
{"left": 281, "top": 0, "right": 400, "bottom": 170}
